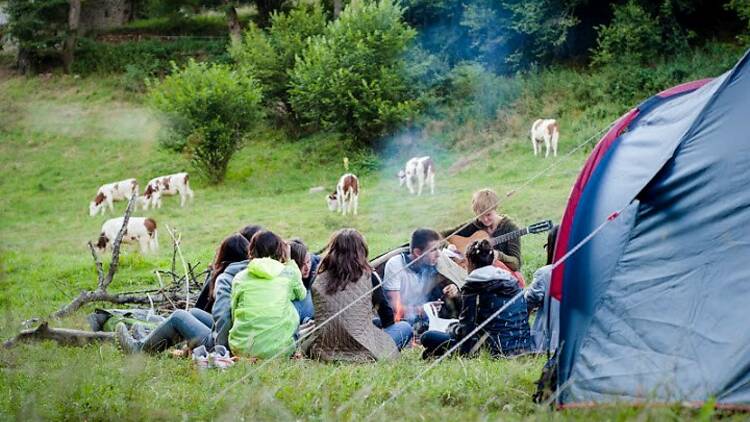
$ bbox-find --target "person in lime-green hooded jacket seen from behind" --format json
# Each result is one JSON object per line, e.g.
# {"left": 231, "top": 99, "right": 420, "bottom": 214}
{"left": 229, "top": 230, "right": 307, "bottom": 358}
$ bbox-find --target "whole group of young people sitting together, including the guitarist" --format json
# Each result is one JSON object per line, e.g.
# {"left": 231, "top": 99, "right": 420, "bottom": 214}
{"left": 115, "top": 189, "right": 557, "bottom": 361}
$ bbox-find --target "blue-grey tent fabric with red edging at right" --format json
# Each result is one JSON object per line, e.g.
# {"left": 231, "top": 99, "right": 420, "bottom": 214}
{"left": 552, "top": 50, "right": 750, "bottom": 406}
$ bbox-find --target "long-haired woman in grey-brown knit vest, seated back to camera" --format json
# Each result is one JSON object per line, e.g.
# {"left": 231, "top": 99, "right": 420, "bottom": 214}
{"left": 306, "top": 229, "right": 412, "bottom": 361}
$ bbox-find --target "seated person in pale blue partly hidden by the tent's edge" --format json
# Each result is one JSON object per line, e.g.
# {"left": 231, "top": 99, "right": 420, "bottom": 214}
{"left": 524, "top": 226, "right": 560, "bottom": 353}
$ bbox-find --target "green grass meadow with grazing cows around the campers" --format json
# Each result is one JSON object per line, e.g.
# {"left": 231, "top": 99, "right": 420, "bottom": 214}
{"left": 0, "top": 66, "right": 740, "bottom": 420}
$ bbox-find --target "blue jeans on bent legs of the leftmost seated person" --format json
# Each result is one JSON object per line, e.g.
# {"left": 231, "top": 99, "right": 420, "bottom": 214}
{"left": 142, "top": 308, "right": 213, "bottom": 353}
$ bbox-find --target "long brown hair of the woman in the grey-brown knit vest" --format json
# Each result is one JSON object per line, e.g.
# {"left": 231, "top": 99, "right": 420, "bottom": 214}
{"left": 318, "top": 229, "right": 372, "bottom": 295}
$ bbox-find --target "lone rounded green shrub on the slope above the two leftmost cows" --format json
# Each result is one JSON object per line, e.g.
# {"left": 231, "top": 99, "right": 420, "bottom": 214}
{"left": 148, "top": 59, "right": 262, "bottom": 183}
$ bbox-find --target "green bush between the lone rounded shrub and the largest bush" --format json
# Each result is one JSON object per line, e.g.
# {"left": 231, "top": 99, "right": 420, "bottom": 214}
{"left": 230, "top": 4, "right": 326, "bottom": 103}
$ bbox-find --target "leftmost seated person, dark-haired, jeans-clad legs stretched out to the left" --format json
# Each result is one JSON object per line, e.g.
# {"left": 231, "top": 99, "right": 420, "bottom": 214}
{"left": 115, "top": 234, "right": 249, "bottom": 353}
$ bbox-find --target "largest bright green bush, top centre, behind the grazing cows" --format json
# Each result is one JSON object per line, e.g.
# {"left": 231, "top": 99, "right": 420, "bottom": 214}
{"left": 289, "top": 0, "right": 416, "bottom": 144}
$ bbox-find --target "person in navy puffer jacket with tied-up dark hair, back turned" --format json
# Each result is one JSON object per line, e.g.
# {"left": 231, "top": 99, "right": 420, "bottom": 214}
{"left": 421, "top": 240, "right": 531, "bottom": 359}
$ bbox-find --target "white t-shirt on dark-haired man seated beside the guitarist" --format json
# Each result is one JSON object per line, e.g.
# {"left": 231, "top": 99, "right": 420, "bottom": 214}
{"left": 383, "top": 254, "right": 437, "bottom": 306}
